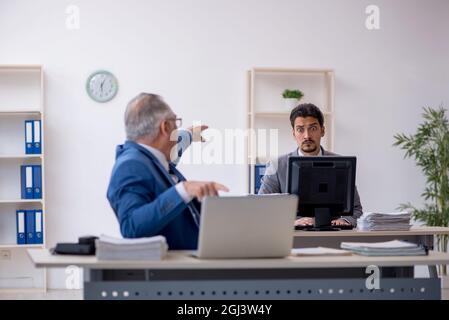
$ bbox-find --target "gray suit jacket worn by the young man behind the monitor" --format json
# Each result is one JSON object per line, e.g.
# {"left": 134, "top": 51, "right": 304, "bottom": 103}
{"left": 259, "top": 147, "right": 363, "bottom": 226}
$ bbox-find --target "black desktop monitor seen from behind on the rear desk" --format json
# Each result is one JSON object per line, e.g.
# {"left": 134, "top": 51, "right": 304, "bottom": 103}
{"left": 287, "top": 156, "right": 356, "bottom": 231}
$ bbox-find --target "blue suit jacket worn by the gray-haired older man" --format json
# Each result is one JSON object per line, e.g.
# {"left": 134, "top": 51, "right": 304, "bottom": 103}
{"left": 107, "top": 141, "right": 200, "bottom": 250}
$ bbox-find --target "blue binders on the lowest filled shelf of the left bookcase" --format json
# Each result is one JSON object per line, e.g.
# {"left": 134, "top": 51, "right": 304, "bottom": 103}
{"left": 16, "top": 210, "right": 44, "bottom": 244}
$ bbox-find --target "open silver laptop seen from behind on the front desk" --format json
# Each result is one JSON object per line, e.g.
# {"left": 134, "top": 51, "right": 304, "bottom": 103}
{"left": 195, "top": 194, "right": 298, "bottom": 259}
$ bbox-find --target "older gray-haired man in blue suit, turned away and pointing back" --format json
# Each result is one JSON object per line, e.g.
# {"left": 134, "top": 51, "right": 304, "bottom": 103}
{"left": 107, "top": 93, "right": 228, "bottom": 250}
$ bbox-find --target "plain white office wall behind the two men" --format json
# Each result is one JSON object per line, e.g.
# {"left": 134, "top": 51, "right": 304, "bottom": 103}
{"left": 0, "top": 0, "right": 449, "bottom": 287}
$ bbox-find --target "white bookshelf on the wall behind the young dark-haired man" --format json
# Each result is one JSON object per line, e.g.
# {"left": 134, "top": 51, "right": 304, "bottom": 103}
{"left": 245, "top": 68, "right": 335, "bottom": 193}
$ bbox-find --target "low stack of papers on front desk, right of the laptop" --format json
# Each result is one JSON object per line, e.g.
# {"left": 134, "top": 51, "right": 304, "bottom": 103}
{"left": 341, "top": 240, "right": 427, "bottom": 256}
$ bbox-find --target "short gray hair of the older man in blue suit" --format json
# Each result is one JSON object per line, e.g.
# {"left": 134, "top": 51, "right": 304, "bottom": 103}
{"left": 125, "top": 93, "right": 173, "bottom": 141}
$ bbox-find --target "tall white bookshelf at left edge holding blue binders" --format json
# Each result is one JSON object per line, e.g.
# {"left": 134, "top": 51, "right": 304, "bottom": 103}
{"left": 0, "top": 65, "right": 47, "bottom": 291}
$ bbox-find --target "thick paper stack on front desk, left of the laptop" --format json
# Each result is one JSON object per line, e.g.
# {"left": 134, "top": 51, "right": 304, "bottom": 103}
{"left": 95, "top": 235, "right": 168, "bottom": 260}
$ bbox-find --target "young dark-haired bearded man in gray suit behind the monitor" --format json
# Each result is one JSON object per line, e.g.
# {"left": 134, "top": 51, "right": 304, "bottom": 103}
{"left": 259, "top": 103, "right": 363, "bottom": 226}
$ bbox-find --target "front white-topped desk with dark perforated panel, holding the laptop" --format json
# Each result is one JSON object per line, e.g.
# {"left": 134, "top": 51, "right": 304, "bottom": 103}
{"left": 28, "top": 249, "right": 449, "bottom": 300}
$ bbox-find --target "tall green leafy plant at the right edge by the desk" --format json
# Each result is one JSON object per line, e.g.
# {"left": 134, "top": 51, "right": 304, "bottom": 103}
{"left": 394, "top": 107, "right": 449, "bottom": 288}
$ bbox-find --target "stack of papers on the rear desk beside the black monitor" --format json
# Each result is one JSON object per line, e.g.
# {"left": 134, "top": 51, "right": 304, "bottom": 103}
{"left": 357, "top": 212, "right": 411, "bottom": 231}
